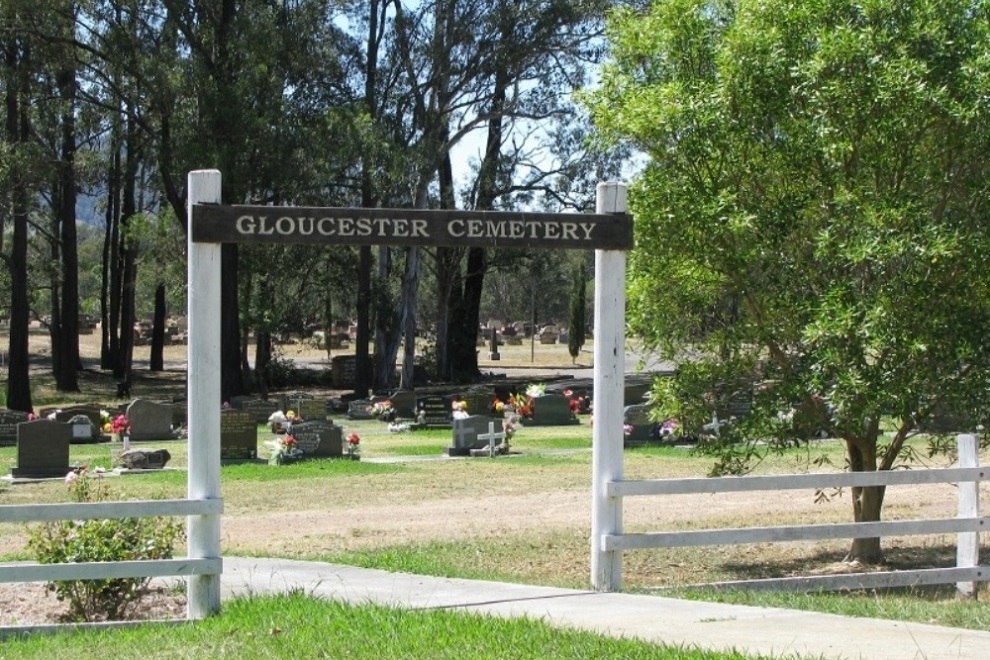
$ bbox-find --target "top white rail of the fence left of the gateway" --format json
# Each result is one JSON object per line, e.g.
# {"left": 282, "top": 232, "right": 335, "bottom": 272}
{"left": 0, "top": 500, "right": 223, "bottom": 522}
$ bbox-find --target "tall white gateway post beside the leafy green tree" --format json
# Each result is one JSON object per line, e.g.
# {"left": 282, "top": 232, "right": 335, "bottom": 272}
{"left": 591, "top": 182, "right": 626, "bottom": 591}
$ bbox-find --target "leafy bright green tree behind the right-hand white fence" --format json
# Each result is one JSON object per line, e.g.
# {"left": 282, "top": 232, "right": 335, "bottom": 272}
{"left": 587, "top": 0, "right": 990, "bottom": 562}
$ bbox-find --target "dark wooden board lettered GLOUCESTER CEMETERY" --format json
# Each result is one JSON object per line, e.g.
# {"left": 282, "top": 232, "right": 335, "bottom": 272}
{"left": 192, "top": 204, "right": 633, "bottom": 250}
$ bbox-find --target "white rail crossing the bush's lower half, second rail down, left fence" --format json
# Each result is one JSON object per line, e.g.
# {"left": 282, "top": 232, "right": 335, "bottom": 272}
{"left": 0, "top": 558, "right": 223, "bottom": 582}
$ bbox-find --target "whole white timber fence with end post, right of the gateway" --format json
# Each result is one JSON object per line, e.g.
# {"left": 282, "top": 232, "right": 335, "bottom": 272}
{"left": 599, "top": 435, "right": 990, "bottom": 595}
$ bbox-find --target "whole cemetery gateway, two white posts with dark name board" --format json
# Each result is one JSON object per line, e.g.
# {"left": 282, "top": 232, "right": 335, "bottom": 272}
{"left": 187, "top": 170, "right": 633, "bottom": 618}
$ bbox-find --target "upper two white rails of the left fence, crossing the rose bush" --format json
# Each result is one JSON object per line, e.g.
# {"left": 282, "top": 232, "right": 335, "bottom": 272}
{"left": 0, "top": 499, "right": 223, "bottom": 583}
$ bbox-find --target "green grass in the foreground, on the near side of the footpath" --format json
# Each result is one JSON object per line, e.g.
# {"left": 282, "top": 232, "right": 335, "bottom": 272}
{"left": 0, "top": 592, "right": 764, "bottom": 660}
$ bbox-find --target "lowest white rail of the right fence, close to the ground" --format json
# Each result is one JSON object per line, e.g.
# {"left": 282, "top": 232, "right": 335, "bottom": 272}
{"left": 698, "top": 568, "right": 990, "bottom": 592}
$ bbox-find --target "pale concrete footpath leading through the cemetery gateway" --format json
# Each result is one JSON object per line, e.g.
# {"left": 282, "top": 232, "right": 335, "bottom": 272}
{"left": 221, "top": 557, "right": 990, "bottom": 660}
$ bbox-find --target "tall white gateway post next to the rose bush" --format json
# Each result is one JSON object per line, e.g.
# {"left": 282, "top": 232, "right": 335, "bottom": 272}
{"left": 186, "top": 170, "right": 221, "bottom": 619}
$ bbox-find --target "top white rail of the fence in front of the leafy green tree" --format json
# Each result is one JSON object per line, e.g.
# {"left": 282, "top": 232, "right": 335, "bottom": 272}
{"left": 605, "top": 466, "right": 987, "bottom": 496}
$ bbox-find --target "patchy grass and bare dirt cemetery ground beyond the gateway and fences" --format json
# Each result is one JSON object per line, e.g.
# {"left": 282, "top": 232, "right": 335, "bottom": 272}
{"left": 0, "top": 330, "right": 990, "bottom": 640}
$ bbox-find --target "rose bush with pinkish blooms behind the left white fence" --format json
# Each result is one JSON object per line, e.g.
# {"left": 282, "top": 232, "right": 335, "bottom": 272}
{"left": 28, "top": 472, "right": 185, "bottom": 621}
